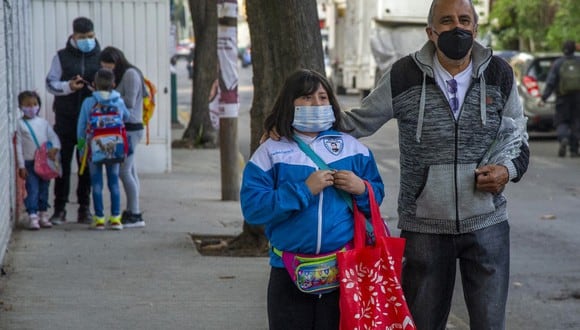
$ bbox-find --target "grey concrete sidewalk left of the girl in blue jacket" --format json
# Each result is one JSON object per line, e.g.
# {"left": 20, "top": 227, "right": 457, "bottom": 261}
{"left": 0, "top": 129, "right": 269, "bottom": 330}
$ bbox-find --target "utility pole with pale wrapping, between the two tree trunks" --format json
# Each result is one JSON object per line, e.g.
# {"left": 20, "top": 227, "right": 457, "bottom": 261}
{"left": 217, "top": 0, "right": 240, "bottom": 201}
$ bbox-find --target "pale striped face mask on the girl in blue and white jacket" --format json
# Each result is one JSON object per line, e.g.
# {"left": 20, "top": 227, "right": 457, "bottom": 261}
{"left": 292, "top": 104, "right": 335, "bottom": 133}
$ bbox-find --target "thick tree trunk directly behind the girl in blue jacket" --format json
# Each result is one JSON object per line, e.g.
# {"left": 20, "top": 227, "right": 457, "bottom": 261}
{"left": 230, "top": 0, "right": 324, "bottom": 249}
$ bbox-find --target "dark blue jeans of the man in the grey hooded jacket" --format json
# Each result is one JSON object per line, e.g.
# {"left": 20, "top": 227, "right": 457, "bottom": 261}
{"left": 401, "top": 221, "right": 510, "bottom": 330}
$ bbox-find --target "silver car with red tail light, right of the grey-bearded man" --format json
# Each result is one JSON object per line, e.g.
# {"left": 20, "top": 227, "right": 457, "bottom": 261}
{"left": 509, "top": 53, "right": 561, "bottom": 132}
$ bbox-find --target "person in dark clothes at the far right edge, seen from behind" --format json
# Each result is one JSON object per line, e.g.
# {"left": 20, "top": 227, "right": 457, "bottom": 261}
{"left": 538, "top": 40, "right": 580, "bottom": 157}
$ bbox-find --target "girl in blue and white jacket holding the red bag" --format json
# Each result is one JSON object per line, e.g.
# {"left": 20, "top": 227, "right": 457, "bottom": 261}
{"left": 240, "top": 70, "right": 384, "bottom": 330}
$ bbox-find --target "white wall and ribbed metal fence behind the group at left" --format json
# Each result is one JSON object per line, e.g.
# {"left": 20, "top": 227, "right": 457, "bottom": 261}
{"left": 0, "top": 0, "right": 171, "bottom": 265}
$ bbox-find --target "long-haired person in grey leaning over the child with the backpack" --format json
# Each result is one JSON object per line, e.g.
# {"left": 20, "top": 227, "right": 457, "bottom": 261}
{"left": 100, "top": 47, "right": 146, "bottom": 228}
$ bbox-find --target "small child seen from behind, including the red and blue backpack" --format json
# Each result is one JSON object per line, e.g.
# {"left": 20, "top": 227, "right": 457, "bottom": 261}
{"left": 77, "top": 69, "right": 129, "bottom": 230}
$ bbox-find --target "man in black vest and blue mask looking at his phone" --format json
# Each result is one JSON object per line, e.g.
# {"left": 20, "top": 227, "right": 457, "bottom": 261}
{"left": 46, "top": 17, "right": 101, "bottom": 225}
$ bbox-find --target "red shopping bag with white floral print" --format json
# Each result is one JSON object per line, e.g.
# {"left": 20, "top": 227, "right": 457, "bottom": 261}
{"left": 337, "top": 182, "right": 415, "bottom": 330}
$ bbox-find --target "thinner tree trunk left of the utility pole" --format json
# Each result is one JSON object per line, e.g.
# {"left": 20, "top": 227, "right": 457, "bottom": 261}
{"left": 173, "top": 0, "right": 218, "bottom": 148}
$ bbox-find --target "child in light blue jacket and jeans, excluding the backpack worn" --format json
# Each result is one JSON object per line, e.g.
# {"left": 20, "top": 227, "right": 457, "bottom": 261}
{"left": 77, "top": 69, "right": 129, "bottom": 230}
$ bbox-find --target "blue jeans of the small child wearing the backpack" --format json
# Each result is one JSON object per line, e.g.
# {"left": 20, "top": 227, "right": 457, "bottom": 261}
{"left": 89, "top": 162, "right": 121, "bottom": 217}
